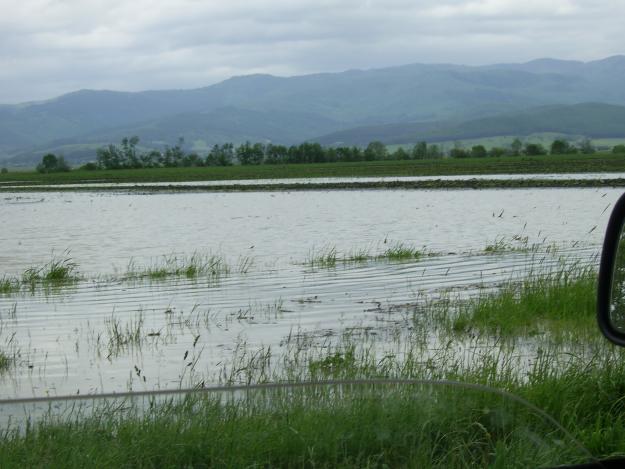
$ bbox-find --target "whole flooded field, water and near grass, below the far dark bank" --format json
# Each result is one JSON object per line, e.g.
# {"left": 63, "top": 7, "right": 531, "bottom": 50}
{"left": 0, "top": 188, "right": 625, "bottom": 467}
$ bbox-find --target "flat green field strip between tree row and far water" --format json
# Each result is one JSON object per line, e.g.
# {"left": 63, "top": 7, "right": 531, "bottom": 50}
{"left": 0, "top": 153, "right": 625, "bottom": 184}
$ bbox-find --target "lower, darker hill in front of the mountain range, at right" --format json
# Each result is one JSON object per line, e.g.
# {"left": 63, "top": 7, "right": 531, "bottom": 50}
{"left": 312, "top": 103, "right": 625, "bottom": 145}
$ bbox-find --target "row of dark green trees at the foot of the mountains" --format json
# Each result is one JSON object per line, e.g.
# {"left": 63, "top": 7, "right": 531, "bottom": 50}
{"left": 37, "top": 136, "right": 625, "bottom": 173}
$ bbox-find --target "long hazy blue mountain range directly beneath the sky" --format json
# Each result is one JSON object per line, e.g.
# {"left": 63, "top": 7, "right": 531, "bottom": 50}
{"left": 0, "top": 56, "right": 625, "bottom": 163}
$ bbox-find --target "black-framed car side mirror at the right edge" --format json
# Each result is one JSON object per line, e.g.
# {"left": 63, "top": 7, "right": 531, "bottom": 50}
{"left": 597, "top": 194, "right": 625, "bottom": 346}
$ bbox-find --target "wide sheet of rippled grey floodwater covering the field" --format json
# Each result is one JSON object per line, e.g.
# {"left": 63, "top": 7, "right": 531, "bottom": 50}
{"left": 0, "top": 189, "right": 622, "bottom": 397}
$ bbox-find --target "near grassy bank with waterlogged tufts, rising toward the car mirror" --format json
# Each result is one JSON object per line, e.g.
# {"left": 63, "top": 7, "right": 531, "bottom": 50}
{"left": 0, "top": 270, "right": 625, "bottom": 467}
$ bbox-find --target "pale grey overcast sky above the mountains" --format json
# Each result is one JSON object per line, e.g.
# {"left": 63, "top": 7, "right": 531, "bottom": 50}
{"left": 0, "top": 0, "right": 625, "bottom": 103}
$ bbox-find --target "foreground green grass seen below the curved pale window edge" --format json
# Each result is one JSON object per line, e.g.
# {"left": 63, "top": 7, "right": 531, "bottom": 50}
{"left": 0, "top": 380, "right": 596, "bottom": 468}
